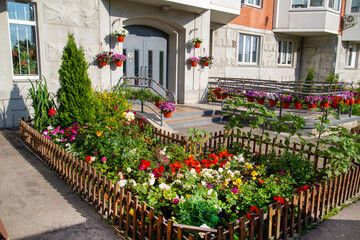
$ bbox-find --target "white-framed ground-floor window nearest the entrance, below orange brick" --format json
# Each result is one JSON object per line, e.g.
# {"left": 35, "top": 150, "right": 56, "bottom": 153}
{"left": 238, "top": 34, "right": 260, "bottom": 64}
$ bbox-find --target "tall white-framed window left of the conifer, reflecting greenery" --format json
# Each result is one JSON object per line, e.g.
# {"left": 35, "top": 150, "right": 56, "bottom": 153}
{"left": 7, "top": 1, "right": 39, "bottom": 76}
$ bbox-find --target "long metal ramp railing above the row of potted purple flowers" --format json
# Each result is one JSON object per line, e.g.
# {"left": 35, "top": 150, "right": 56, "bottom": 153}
{"left": 208, "top": 77, "right": 354, "bottom": 118}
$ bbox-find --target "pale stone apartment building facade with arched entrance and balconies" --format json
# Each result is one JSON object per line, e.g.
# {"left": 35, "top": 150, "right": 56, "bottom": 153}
{"left": 0, "top": 0, "right": 360, "bottom": 128}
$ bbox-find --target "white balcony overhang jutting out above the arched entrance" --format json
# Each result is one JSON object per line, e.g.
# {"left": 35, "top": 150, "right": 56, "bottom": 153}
{"left": 125, "top": 0, "right": 241, "bottom": 24}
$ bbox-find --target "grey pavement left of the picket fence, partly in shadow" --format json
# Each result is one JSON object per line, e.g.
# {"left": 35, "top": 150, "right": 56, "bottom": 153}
{"left": 0, "top": 130, "right": 122, "bottom": 240}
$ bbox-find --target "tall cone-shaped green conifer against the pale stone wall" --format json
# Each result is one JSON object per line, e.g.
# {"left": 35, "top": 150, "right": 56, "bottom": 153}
{"left": 57, "top": 34, "right": 94, "bottom": 127}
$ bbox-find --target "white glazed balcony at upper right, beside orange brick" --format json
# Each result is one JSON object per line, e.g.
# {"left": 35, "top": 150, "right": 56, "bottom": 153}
{"left": 274, "top": 0, "right": 340, "bottom": 36}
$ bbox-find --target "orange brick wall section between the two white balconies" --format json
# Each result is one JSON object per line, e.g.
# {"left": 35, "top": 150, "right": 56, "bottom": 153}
{"left": 230, "top": 0, "right": 274, "bottom": 30}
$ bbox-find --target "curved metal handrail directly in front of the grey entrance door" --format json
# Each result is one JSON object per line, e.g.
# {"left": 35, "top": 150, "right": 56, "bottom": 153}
{"left": 117, "top": 77, "right": 176, "bottom": 126}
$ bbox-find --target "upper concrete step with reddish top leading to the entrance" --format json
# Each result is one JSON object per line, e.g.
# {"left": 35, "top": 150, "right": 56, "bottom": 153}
{"left": 165, "top": 115, "right": 224, "bottom": 128}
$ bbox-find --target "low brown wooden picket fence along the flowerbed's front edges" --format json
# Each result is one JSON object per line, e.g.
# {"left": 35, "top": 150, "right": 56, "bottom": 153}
{"left": 20, "top": 120, "right": 360, "bottom": 240}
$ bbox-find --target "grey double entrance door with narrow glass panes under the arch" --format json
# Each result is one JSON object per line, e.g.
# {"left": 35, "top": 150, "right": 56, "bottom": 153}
{"left": 123, "top": 26, "right": 168, "bottom": 88}
